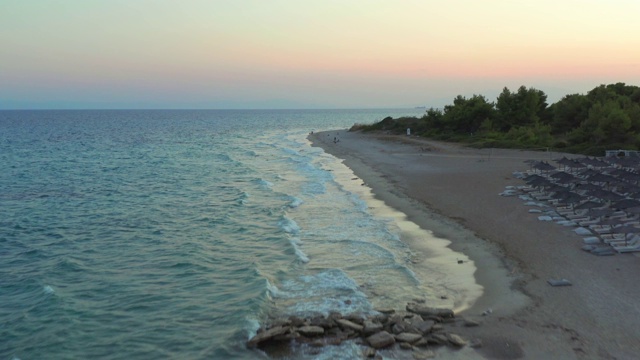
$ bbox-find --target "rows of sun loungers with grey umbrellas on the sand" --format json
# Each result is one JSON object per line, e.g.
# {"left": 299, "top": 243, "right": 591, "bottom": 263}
{"left": 500, "top": 156, "right": 640, "bottom": 256}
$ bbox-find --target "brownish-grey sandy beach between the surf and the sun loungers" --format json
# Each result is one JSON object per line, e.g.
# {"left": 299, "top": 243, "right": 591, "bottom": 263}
{"left": 309, "top": 130, "right": 640, "bottom": 359}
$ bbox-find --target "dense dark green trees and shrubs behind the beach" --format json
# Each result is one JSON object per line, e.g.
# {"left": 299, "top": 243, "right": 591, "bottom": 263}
{"left": 354, "top": 83, "right": 640, "bottom": 156}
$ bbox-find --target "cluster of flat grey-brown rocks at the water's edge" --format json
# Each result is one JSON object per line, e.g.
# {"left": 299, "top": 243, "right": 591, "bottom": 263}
{"left": 247, "top": 302, "right": 481, "bottom": 358}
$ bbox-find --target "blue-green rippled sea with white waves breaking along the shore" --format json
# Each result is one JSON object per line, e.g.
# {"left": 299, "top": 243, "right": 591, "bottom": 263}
{"left": 0, "top": 109, "right": 478, "bottom": 360}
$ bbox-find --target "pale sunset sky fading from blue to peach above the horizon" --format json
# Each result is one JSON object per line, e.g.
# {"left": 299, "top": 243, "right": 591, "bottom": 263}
{"left": 0, "top": 0, "right": 640, "bottom": 109}
